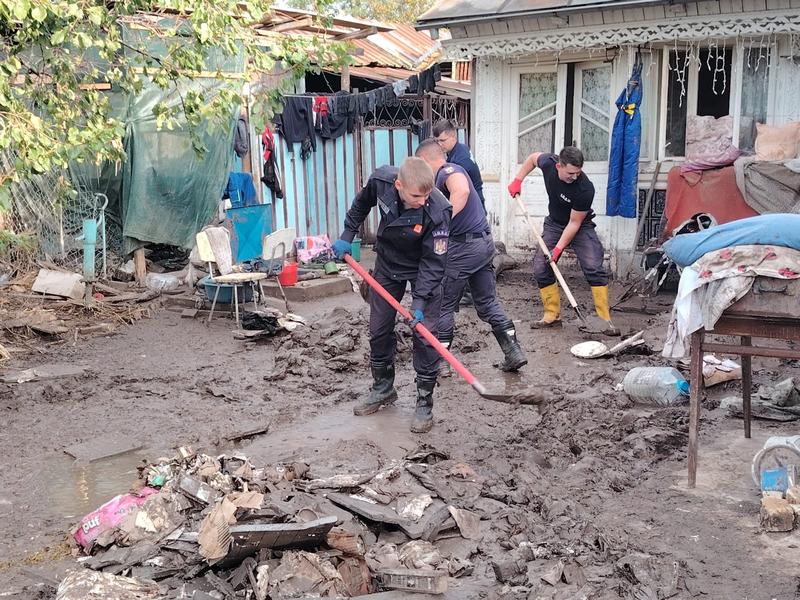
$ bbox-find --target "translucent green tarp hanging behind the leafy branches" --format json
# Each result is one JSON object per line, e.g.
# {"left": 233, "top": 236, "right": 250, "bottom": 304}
{"left": 70, "top": 19, "right": 244, "bottom": 254}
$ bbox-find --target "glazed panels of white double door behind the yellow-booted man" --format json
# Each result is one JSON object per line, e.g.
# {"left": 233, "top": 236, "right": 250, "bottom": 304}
{"left": 517, "top": 62, "right": 614, "bottom": 163}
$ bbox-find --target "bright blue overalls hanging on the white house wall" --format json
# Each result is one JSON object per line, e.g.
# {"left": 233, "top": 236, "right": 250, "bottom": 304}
{"left": 606, "top": 54, "right": 643, "bottom": 219}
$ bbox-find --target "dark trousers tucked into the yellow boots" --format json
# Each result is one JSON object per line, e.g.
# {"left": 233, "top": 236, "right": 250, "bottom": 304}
{"left": 533, "top": 217, "right": 608, "bottom": 288}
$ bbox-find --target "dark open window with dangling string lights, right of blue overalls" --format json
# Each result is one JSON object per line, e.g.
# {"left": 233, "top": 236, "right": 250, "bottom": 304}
{"left": 664, "top": 45, "right": 733, "bottom": 157}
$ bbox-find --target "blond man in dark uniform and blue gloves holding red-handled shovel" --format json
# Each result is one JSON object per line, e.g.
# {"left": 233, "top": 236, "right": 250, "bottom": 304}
{"left": 333, "top": 157, "right": 452, "bottom": 433}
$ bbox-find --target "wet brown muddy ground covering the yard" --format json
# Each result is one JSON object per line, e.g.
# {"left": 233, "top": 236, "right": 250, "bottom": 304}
{"left": 0, "top": 251, "right": 800, "bottom": 599}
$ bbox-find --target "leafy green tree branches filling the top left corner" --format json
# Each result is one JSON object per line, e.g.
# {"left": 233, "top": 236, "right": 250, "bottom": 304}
{"left": 0, "top": 0, "right": 347, "bottom": 207}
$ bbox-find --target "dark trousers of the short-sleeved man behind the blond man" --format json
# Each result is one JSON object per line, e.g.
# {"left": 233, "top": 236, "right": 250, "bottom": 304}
{"left": 439, "top": 234, "right": 508, "bottom": 333}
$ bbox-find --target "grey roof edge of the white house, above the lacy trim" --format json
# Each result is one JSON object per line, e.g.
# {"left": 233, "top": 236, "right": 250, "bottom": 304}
{"left": 416, "top": 0, "right": 688, "bottom": 29}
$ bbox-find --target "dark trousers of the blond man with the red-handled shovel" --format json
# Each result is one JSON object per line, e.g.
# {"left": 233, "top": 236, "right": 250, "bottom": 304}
{"left": 369, "top": 268, "right": 442, "bottom": 377}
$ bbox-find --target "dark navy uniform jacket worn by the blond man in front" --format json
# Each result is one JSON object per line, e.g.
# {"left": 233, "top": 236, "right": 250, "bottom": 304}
{"left": 341, "top": 166, "right": 453, "bottom": 310}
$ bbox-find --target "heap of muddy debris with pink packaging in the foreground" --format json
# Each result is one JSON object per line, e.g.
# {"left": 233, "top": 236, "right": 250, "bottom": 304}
{"left": 57, "top": 447, "right": 485, "bottom": 600}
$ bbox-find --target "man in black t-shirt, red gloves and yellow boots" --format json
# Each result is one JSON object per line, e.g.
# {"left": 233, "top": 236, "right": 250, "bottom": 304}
{"left": 508, "top": 146, "right": 619, "bottom": 335}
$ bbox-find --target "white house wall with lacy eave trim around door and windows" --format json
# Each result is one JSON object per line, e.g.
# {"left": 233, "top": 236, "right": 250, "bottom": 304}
{"left": 466, "top": 0, "right": 800, "bottom": 273}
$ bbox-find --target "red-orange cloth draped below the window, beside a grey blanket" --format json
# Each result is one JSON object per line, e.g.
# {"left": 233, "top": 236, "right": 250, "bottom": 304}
{"left": 661, "top": 167, "right": 758, "bottom": 241}
